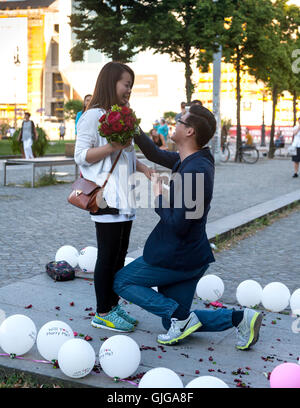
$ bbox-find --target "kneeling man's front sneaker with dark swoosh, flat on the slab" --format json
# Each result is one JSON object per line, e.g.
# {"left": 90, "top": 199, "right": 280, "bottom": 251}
{"left": 157, "top": 312, "right": 202, "bottom": 345}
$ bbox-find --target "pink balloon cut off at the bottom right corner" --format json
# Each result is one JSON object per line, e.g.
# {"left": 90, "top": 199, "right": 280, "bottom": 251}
{"left": 270, "top": 363, "right": 300, "bottom": 388}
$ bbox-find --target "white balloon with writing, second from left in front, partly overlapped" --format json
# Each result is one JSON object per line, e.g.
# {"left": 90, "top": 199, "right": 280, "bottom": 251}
{"left": 36, "top": 320, "right": 74, "bottom": 361}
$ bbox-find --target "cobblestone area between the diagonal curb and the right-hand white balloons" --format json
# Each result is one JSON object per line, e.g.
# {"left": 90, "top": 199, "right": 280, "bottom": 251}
{"left": 206, "top": 211, "right": 300, "bottom": 304}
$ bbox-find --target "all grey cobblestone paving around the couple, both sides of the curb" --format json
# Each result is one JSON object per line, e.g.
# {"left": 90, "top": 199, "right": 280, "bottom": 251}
{"left": 0, "top": 159, "right": 300, "bottom": 289}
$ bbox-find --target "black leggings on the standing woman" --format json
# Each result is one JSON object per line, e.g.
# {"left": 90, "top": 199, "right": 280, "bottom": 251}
{"left": 94, "top": 221, "right": 132, "bottom": 313}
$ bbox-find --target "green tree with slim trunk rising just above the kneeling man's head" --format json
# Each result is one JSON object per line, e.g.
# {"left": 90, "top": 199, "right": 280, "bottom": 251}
{"left": 130, "top": 0, "right": 228, "bottom": 102}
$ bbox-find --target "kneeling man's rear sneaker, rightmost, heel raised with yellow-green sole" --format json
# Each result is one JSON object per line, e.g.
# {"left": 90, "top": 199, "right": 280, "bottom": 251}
{"left": 236, "top": 309, "right": 263, "bottom": 350}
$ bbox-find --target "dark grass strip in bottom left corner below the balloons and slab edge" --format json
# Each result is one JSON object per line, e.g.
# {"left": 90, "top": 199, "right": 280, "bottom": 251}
{"left": 0, "top": 372, "right": 64, "bottom": 388}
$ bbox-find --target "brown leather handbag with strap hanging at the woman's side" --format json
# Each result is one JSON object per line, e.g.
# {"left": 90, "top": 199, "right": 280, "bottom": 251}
{"left": 68, "top": 150, "right": 122, "bottom": 213}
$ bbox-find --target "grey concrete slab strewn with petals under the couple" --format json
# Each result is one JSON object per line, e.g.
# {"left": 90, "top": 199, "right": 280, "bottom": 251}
{"left": 0, "top": 274, "right": 300, "bottom": 389}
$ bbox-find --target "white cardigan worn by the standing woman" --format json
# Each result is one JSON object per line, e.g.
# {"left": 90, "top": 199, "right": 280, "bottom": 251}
{"left": 75, "top": 108, "right": 136, "bottom": 216}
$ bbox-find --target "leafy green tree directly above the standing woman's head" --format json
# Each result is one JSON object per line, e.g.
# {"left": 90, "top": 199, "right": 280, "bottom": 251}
{"left": 70, "top": 0, "right": 142, "bottom": 62}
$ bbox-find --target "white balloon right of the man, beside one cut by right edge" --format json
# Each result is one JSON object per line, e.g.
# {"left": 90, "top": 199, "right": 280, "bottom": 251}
{"left": 261, "top": 282, "right": 291, "bottom": 312}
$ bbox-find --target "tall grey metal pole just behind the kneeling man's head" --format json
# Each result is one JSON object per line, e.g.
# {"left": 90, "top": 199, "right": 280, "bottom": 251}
{"left": 212, "top": 0, "right": 222, "bottom": 164}
